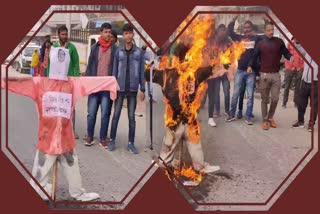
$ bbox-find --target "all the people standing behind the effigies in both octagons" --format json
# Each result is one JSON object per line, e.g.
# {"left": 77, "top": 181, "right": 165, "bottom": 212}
{"left": 31, "top": 16, "right": 318, "bottom": 164}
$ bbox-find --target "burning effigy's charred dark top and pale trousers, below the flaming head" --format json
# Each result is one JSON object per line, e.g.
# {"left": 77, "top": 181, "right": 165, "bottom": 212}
{"left": 146, "top": 59, "right": 219, "bottom": 172}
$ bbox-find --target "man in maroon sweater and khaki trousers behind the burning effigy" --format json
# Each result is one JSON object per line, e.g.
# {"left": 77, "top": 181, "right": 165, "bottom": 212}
{"left": 247, "top": 22, "right": 292, "bottom": 130}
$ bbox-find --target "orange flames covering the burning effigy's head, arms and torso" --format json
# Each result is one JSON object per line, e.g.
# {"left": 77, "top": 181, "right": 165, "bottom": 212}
{"left": 159, "top": 15, "right": 245, "bottom": 143}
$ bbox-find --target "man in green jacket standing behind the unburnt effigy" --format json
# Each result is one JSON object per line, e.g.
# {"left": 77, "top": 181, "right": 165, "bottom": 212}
{"left": 46, "top": 25, "right": 80, "bottom": 139}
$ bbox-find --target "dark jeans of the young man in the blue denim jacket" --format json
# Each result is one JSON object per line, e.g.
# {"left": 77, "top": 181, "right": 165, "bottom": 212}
{"left": 110, "top": 92, "right": 137, "bottom": 143}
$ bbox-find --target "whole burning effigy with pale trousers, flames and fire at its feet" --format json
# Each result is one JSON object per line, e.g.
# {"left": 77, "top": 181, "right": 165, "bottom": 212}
{"left": 146, "top": 15, "right": 245, "bottom": 186}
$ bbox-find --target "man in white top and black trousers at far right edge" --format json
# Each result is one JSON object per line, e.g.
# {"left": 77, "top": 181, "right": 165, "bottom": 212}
{"left": 292, "top": 54, "right": 318, "bottom": 132}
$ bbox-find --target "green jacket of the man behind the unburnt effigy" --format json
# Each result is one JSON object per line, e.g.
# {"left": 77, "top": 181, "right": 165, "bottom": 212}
{"left": 45, "top": 42, "right": 80, "bottom": 77}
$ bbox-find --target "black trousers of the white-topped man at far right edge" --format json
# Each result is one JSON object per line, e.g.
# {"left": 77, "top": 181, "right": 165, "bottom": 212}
{"left": 298, "top": 80, "right": 318, "bottom": 125}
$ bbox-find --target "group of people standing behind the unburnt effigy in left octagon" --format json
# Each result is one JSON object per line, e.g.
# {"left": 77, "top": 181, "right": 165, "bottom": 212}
{"left": 31, "top": 23, "right": 145, "bottom": 154}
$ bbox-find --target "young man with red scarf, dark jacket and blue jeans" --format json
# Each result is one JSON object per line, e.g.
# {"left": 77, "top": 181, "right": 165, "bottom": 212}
{"left": 85, "top": 23, "right": 117, "bottom": 149}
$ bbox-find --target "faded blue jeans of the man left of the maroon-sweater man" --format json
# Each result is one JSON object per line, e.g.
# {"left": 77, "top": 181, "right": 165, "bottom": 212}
{"left": 230, "top": 70, "right": 256, "bottom": 118}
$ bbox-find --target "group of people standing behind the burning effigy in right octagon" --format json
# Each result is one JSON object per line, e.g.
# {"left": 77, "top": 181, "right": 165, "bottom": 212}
{"left": 198, "top": 16, "right": 318, "bottom": 131}
